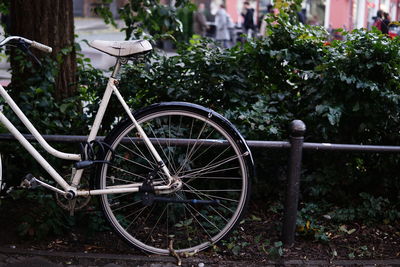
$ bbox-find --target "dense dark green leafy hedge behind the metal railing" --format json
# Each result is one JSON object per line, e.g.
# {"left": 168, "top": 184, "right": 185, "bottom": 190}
{"left": 0, "top": 12, "right": 400, "bottom": 239}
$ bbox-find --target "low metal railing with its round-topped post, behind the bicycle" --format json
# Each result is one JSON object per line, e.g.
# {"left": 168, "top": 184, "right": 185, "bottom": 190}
{"left": 0, "top": 120, "right": 400, "bottom": 247}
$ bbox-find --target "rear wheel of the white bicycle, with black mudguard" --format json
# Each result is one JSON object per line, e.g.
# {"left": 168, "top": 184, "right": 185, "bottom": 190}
{"left": 97, "top": 102, "right": 253, "bottom": 255}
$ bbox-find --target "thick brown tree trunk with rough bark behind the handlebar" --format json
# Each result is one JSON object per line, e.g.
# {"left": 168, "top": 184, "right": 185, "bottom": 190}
{"left": 10, "top": 0, "right": 76, "bottom": 100}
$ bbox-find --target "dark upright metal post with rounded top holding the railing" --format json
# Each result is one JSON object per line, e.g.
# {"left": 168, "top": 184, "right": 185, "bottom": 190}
{"left": 282, "top": 120, "right": 306, "bottom": 247}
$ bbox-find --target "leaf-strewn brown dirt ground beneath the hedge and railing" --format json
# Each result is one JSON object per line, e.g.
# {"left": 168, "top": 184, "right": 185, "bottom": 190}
{"left": 0, "top": 201, "right": 400, "bottom": 263}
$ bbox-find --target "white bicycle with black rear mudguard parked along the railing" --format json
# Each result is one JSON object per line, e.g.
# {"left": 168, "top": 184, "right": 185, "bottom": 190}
{"left": 0, "top": 36, "right": 253, "bottom": 255}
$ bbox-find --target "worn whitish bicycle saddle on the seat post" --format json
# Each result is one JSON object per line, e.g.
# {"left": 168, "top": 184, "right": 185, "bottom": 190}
{"left": 89, "top": 40, "right": 152, "bottom": 57}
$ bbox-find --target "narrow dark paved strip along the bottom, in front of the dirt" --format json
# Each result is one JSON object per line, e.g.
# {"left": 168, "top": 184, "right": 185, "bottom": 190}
{"left": 0, "top": 247, "right": 400, "bottom": 267}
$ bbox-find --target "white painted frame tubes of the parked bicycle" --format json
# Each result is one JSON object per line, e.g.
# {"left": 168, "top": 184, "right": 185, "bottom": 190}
{"left": 0, "top": 39, "right": 174, "bottom": 196}
